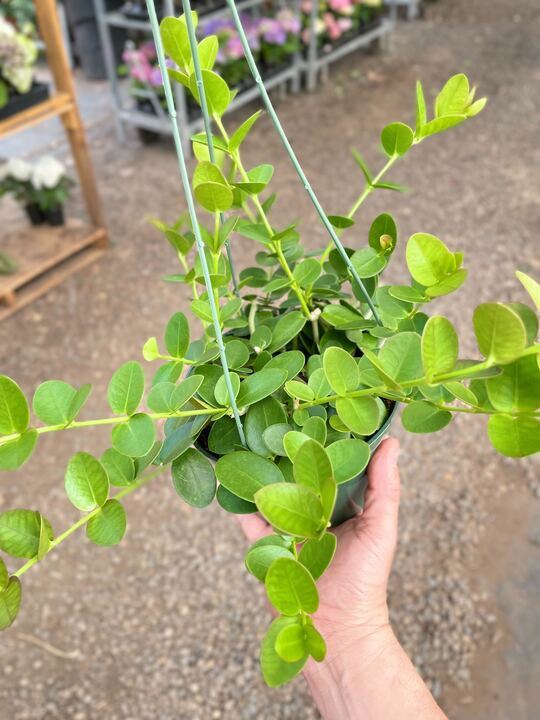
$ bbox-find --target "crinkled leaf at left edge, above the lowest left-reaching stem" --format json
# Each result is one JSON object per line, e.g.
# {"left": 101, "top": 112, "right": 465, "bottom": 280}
{"left": 0, "top": 510, "right": 54, "bottom": 558}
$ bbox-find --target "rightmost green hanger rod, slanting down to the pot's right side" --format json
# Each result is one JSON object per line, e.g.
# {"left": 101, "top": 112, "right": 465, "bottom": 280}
{"left": 227, "top": 0, "right": 382, "bottom": 325}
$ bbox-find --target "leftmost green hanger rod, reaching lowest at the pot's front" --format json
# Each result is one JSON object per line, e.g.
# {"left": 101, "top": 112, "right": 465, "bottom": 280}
{"left": 146, "top": 0, "right": 246, "bottom": 447}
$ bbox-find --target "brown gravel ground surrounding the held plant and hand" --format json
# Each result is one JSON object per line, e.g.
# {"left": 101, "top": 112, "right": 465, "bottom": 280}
{"left": 0, "top": 0, "right": 540, "bottom": 720}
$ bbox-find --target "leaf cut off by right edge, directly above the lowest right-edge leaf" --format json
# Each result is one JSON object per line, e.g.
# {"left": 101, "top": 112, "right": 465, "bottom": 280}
{"left": 486, "top": 355, "right": 540, "bottom": 413}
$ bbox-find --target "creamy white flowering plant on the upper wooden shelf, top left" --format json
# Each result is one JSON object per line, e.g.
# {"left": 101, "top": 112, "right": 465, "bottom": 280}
{"left": 0, "top": 16, "right": 49, "bottom": 120}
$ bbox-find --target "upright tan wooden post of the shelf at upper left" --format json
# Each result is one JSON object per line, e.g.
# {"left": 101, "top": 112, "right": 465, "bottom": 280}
{"left": 35, "top": 0, "right": 106, "bottom": 233}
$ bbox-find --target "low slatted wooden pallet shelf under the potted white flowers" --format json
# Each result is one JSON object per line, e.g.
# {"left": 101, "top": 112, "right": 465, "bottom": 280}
{"left": 0, "top": 222, "right": 106, "bottom": 320}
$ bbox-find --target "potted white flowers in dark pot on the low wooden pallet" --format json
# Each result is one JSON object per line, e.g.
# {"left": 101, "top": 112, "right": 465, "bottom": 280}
{"left": 0, "top": 156, "right": 73, "bottom": 225}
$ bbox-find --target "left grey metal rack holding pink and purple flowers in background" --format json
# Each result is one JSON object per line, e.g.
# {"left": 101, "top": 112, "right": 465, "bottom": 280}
{"left": 94, "top": 0, "right": 302, "bottom": 155}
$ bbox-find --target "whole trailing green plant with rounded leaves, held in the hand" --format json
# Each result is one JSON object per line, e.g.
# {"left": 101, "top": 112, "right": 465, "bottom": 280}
{"left": 0, "top": 8, "right": 540, "bottom": 686}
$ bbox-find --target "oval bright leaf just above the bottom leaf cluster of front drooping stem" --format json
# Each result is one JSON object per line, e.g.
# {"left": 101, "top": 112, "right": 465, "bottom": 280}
{"left": 264, "top": 557, "right": 319, "bottom": 616}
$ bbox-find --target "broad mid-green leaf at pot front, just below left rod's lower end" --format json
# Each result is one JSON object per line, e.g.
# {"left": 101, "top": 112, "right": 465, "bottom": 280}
{"left": 216, "top": 451, "right": 283, "bottom": 502}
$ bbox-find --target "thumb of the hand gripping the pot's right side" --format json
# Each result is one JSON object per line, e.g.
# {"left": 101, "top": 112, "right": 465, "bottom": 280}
{"left": 361, "top": 438, "right": 400, "bottom": 571}
